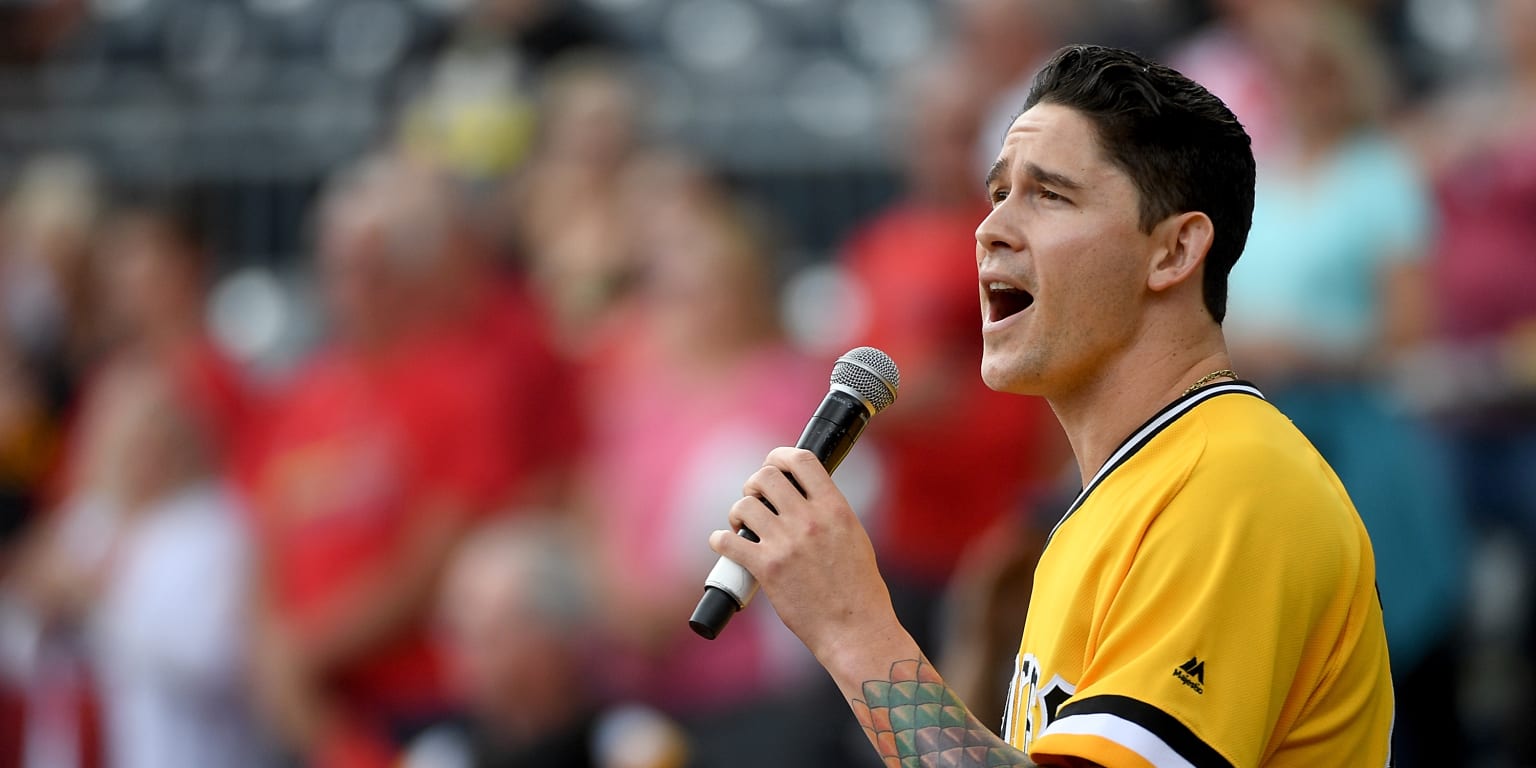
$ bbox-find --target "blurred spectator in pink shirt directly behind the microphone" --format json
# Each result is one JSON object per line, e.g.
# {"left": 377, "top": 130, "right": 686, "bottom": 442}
{"left": 578, "top": 157, "right": 869, "bottom": 766}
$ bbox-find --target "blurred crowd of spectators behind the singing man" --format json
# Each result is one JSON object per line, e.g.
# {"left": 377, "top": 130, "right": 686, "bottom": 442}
{"left": 0, "top": 0, "right": 1536, "bottom": 768}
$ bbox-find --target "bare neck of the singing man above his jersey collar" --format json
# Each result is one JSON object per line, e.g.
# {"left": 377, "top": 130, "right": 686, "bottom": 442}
{"left": 1046, "top": 330, "right": 1232, "bottom": 487}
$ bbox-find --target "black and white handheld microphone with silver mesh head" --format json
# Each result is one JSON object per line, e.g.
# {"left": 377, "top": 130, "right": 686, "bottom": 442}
{"left": 688, "top": 347, "right": 902, "bottom": 641}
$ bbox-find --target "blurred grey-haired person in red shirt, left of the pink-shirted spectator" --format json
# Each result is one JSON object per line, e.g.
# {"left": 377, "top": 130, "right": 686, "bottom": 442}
{"left": 252, "top": 157, "right": 565, "bottom": 766}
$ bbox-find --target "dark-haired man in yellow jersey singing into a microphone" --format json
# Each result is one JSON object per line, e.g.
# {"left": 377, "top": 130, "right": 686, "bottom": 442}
{"left": 710, "top": 46, "right": 1393, "bottom": 768}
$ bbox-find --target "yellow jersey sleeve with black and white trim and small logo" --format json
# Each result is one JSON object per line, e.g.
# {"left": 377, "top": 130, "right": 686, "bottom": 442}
{"left": 1031, "top": 430, "right": 1359, "bottom": 768}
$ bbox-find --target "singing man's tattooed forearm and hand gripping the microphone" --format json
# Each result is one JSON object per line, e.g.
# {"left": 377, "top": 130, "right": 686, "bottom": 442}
{"left": 710, "top": 449, "right": 1034, "bottom": 768}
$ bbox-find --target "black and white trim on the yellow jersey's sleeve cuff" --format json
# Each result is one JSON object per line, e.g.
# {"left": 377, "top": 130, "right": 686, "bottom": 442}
{"left": 1041, "top": 694, "right": 1232, "bottom": 768}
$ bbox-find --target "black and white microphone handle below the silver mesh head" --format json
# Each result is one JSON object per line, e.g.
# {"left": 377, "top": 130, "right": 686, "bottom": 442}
{"left": 688, "top": 386, "right": 872, "bottom": 641}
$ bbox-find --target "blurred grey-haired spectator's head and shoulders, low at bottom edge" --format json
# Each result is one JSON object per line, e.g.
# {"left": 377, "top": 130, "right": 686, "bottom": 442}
{"left": 406, "top": 516, "right": 687, "bottom": 768}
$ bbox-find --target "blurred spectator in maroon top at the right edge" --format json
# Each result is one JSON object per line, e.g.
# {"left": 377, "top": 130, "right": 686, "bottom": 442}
{"left": 1401, "top": 0, "right": 1536, "bottom": 762}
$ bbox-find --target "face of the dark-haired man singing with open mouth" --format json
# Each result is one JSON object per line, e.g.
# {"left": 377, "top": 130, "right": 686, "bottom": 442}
{"left": 975, "top": 104, "right": 1152, "bottom": 396}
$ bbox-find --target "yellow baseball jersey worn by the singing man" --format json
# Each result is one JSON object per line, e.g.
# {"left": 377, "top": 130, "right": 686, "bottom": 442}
{"left": 1003, "top": 382, "right": 1393, "bottom": 768}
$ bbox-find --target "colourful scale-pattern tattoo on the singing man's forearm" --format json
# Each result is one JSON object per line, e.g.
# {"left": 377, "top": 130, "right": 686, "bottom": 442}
{"left": 851, "top": 659, "right": 1034, "bottom": 768}
